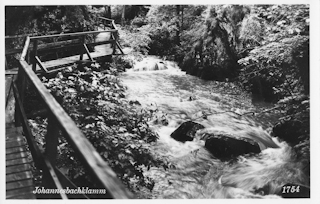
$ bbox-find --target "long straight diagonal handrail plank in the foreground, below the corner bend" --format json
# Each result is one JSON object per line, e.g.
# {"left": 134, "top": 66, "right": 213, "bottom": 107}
{"left": 20, "top": 61, "right": 133, "bottom": 199}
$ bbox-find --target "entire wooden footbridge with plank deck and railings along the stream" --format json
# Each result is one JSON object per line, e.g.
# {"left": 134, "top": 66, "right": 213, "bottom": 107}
{"left": 5, "top": 18, "right": 133, "bottom": 199}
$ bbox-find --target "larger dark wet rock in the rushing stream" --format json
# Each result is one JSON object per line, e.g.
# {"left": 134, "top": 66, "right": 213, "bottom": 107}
{"left": 203, "top": 133, "right": 261, "bottom": 160}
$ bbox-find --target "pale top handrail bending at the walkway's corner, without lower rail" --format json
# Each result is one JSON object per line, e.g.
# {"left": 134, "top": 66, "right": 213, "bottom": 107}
{"left": 14, "top": 31, "right": 133, "bottom": 199}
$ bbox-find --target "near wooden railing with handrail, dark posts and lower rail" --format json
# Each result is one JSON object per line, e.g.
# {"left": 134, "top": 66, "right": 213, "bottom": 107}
{"left": 13, "top": 24, "right": 133, "bottom": 199}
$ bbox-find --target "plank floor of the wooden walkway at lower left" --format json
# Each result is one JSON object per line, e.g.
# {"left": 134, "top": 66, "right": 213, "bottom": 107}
{"left": 5, "top": 74, "right": 36, "bottom": 199}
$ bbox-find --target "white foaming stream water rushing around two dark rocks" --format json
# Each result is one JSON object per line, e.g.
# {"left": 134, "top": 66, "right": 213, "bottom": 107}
{"left": 121, "top": 60, "right": 309, "bottom": 198}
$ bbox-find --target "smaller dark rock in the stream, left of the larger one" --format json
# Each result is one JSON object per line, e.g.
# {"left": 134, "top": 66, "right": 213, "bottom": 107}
{"left": 170, "top": 121, "right": 204, "bottom": 142}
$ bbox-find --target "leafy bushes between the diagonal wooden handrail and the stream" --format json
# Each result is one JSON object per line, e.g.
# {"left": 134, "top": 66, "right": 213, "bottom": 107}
{"left": 30, "top": 64, "right": 167, "bottom": 192}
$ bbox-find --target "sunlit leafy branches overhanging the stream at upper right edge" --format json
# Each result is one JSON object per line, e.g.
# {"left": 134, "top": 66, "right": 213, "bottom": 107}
{"left": 238, "top": 5, "right": 309, "bottom": 99}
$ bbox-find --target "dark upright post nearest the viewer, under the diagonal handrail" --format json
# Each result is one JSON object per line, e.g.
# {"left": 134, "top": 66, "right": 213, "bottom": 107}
{"left": 45, "top": 114, "right": 60, "bottom": 165}
